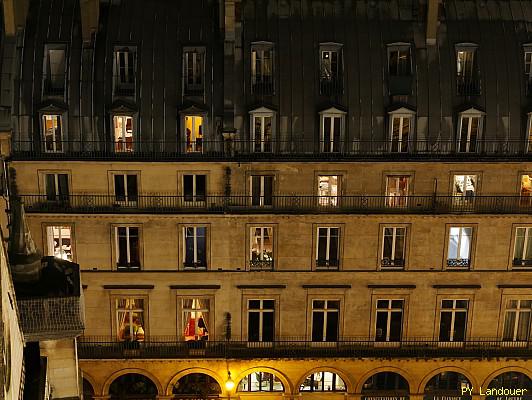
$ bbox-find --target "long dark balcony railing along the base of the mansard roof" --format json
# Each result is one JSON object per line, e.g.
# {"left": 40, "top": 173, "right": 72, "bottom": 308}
{"left": 13, "top": 138, "right": 532, "bottom": 161}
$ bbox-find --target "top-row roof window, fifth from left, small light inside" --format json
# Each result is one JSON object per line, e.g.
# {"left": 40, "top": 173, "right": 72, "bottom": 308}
{"left": 320, "top": 43, "right": 343, "bottom": 96}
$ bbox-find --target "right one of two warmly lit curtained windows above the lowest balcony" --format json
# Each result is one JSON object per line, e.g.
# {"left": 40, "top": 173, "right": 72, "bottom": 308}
{"left": 182, "top": 297, "right": 210, "bottom": 342}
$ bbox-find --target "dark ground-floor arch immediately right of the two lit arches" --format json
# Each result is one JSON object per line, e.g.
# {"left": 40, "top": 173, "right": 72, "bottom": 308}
{"left": 362, "top": 371, "right": 410, "bottom": 400}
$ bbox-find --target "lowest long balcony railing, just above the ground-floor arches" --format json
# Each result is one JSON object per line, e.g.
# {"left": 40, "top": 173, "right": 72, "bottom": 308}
{"left": 78, "top": 337, "right": 532, "bottom": 359}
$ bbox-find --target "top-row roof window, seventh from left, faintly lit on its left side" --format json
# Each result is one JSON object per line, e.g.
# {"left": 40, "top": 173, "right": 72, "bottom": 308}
{"left": 456, "top": 43, "right": 480, "bottom": 96}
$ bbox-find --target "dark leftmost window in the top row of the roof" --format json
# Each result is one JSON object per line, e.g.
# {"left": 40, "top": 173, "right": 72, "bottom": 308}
{"left": 43, "top": 44, "right": 66, "bottom": 97}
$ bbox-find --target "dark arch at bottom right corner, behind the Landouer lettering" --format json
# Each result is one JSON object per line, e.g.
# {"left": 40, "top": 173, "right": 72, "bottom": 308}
{"left": 483, "top": 371, "right": 532, "bottom": 400}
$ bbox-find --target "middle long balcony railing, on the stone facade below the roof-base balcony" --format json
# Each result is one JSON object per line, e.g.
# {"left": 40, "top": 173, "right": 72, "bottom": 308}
{"left": 20, "top": 194, "right": 532, "bottom": 214}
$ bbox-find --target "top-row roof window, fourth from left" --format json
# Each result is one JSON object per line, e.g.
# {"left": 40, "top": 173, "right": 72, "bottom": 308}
{"left": 251, "top": 42, "right": 274, "bottom": 95}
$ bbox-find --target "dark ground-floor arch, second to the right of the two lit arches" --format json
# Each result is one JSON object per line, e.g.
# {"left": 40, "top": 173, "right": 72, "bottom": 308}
{"left": 423, "top": 371, "right": 473, "bottom": 400}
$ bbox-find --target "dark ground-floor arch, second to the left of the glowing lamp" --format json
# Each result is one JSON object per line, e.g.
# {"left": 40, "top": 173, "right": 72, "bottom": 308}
{"left": 109, "top": 374, "right": 157, "bottom": 400}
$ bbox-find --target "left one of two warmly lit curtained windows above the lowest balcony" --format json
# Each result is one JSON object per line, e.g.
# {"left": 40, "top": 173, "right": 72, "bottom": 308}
{"left": 115, "top": 297, "right": 146, "bottom": 342}
